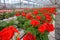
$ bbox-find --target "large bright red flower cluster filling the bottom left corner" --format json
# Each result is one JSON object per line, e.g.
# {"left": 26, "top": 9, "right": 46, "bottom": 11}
{"left": 0, "top": 26, "right": 19, "bottom": 40}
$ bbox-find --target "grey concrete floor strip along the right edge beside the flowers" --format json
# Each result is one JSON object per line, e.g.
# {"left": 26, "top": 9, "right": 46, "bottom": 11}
{"left": 55, "top": 9, "right": 60, "bottom": 40}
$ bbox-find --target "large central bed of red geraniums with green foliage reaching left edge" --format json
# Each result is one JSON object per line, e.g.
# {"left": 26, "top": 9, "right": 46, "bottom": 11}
{"left": 0, "top": 7, "right": 56, "bottom": 40}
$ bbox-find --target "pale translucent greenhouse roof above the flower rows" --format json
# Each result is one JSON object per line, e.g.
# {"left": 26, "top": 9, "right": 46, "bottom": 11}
{"left": 0, "top": 0, "right": 60, "bottom": 8}
